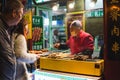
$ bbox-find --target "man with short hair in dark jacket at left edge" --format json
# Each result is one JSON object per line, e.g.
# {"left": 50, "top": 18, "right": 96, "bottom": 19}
{"left": 0, "top": 0, "right": 24, "bottom": 80}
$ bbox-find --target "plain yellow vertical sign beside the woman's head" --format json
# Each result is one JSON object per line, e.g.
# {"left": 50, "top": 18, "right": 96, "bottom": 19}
{"left": 24, "top": 11, "right": 32, "bottom": 39}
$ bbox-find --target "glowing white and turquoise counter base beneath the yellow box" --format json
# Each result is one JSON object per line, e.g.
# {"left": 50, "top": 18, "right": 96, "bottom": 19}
{"left": 32, "top": 70, "right": 100, "bottom": 80}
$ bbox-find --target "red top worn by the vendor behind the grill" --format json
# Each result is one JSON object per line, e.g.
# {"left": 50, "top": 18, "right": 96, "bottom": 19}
{"left": 67, "top": 30, "right": 94, "bottom": 54}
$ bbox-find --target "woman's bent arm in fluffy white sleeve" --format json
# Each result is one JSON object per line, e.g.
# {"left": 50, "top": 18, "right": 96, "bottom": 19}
{"left": 15, "top": 35, "right": 37, "bottom": 63}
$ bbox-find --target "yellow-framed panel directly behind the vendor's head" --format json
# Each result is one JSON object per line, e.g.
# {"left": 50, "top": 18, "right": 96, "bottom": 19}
{"left": 66, "top": 12, "right": 84, "bottom": 39}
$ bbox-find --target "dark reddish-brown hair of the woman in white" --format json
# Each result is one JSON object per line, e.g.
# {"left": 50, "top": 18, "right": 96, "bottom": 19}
{"left": 15, "top": 18, "right": 28, "bottom": 35}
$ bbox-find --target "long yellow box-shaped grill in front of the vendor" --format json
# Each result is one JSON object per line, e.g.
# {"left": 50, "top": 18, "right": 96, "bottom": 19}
{"left": 40, "top": 57, "right": 104, "bottom": 76}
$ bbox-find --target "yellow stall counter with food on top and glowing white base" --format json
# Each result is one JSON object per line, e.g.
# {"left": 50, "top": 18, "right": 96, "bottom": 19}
{"left": 29, "top": 49, "right": 104, "bottom": 80}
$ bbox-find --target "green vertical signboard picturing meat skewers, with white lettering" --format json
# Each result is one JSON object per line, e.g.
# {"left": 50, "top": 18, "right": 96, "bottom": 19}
{"left": 32, "top": 16, "right": 43, "bottom": 50}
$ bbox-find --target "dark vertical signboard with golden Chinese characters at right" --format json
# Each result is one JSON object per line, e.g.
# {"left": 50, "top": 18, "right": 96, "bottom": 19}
{"left": 106, "top": 0, "right": 120, "bottom": 60}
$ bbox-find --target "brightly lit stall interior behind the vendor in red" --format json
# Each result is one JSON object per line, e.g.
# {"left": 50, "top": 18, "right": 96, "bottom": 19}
{"left": 32, "top": 0, "right": 104, "bottom": 57}
